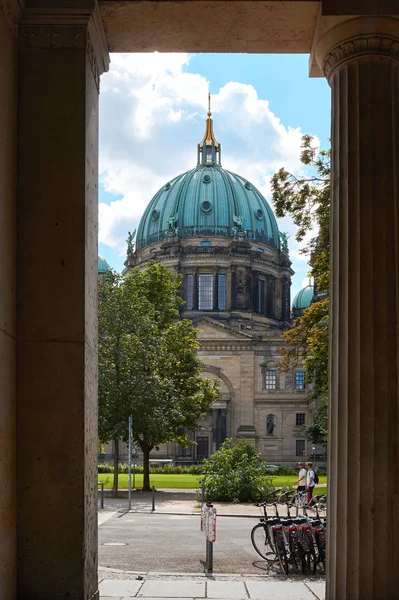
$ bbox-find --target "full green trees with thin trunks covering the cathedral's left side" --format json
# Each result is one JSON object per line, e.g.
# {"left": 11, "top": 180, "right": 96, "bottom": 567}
{"left": 99, "top": 261, "right": 219, "bottom": 495}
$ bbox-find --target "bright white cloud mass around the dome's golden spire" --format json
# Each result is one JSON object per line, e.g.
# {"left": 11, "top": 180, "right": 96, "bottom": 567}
{"left": 99, "top": 53, "right": 314, "bottom": 273}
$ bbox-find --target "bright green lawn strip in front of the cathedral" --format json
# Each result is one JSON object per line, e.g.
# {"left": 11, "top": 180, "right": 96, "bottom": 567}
{"left": 98, "top": 473, "right": 327, "bottom": 494}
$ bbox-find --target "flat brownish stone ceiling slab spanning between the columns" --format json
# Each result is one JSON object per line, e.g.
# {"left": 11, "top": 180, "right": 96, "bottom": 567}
{"left": 99, "top": 0, "right": 320, "bottom": 53}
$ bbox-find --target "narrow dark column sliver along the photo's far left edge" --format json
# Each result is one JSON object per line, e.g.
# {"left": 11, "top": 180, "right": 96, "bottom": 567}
{"left": 0, "top": 1, "right": 20, "bottom": 599}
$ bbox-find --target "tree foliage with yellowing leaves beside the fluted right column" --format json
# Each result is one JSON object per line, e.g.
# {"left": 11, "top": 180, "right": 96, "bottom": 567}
{"left": 272, "top": 135, "right": 331, "bottom": 444}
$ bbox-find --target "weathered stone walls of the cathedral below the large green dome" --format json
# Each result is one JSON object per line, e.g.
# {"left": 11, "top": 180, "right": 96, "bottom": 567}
{"left": 122, "top": 198, "right": 318, "bottom": 463}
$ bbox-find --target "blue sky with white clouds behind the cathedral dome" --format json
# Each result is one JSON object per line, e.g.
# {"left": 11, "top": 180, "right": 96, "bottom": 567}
{"left": 99, "top": 53, "right": 330, "bottom": 297}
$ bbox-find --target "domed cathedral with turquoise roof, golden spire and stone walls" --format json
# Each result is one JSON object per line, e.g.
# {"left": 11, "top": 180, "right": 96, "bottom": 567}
{"left": 103, "top": 103, "right": 315, "bottom": 464}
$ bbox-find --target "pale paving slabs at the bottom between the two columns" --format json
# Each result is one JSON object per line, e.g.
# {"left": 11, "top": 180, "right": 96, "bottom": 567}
{"left": 100, "top": 569, "right": 325, "bottom": 600}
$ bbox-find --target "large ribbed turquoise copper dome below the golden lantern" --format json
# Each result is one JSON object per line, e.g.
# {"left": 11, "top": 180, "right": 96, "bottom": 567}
{"left": 136, "top": 163, "right": 280, "bottom": 250}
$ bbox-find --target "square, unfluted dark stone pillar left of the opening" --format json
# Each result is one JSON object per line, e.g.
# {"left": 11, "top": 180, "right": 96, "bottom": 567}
{"left": 17, "top": 0, "right": 108, "bottom": 600}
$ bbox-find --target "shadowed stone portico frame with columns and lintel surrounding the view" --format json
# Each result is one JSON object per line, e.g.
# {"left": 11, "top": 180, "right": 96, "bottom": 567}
{"left": 0, "top": 0, "right": 399, "bottom": 600}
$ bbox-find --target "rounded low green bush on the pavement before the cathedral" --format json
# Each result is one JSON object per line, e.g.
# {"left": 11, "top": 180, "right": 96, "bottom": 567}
{"left": 200, "top": 438, "right": 273, "bottom": 503}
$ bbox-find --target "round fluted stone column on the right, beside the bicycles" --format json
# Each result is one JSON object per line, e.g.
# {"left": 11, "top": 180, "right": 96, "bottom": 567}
{"left": 316, "top": 18, "right": 399, "bottom": 600}
